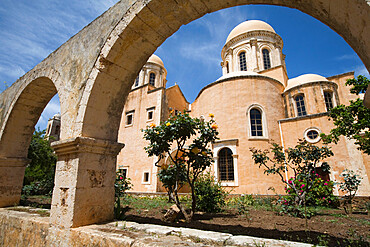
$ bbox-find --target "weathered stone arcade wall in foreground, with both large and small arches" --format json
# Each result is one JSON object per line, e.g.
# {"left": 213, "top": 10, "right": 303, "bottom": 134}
{"left": 0, "top": 0, "right": 370, "bottom": 227}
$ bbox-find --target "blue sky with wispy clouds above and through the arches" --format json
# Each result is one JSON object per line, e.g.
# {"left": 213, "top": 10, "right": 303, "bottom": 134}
{"left": 0, "top": 0, "right": 369, "bottom": 129}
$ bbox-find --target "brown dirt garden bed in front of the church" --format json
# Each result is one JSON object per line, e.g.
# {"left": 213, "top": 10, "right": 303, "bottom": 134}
{"left": 22, "top": 198, "right": 370, "bottom": 246}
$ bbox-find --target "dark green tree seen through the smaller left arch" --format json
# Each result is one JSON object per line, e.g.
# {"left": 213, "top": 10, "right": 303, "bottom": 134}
{"left": 24, "top": 130, "right": 57, "bottom": 192}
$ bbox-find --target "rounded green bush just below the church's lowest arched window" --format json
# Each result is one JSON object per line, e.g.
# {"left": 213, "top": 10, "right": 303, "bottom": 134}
{"left": 195, "top": 173, "right": 228, "bottom": 213}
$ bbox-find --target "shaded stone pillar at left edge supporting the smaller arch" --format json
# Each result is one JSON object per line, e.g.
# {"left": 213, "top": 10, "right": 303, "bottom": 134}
{"left": 0, "top": 158, "right": 29, "bottom": 207}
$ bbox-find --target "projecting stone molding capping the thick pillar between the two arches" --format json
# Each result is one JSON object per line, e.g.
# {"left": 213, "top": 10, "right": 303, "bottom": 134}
{"left": 51, "top": 136, "right": 125, "bottom": 156}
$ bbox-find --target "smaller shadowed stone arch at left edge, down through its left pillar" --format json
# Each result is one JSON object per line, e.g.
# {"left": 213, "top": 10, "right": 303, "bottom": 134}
{"left": 0, "top": 67, "right": 59, "bottom": 206}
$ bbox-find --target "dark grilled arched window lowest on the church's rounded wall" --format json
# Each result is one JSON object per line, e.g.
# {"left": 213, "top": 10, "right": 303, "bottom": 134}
{"left": 218, "top": 148, "right": 235, "bottom": 181}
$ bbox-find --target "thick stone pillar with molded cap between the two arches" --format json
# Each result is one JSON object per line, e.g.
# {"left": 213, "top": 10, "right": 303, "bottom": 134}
{"left": 50, "top": 137, "right": 124, "bottom": 228}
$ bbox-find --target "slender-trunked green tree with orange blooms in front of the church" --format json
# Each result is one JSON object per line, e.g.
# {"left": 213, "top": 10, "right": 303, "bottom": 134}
{"left": 142, "top": 112, "right": 218, "bottom": 222}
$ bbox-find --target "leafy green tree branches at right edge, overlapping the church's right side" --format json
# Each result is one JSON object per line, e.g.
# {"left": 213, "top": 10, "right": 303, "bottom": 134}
{"left": 321, "top": 75, "right": 370, "bottom": 155}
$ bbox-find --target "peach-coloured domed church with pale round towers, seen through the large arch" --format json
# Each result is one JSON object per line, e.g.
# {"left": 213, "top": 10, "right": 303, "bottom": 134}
{"left": 117, "top": 20, "right": 370, "bottom": 196}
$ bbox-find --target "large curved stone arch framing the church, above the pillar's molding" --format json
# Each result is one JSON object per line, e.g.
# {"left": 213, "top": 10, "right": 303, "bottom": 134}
{"left": 78, "top": 0, "right": 370, "bottom": 141}
